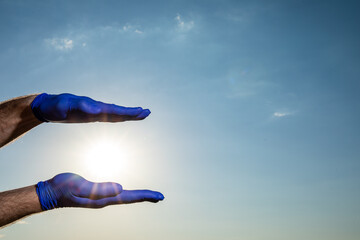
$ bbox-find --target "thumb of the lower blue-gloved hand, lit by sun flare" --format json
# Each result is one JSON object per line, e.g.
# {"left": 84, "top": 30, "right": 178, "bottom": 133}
{"left": 74, "top": 180, "right": 122, "bottom": 199}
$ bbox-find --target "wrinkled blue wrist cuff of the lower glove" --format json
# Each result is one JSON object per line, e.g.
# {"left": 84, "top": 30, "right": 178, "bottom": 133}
{"left": 36, "top": 181, "right": 58, "bottom": 211}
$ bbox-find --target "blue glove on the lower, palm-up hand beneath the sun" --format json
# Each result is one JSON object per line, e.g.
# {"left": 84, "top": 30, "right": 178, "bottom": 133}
{"left": 36, "top": 173, "right": 164, "bottom": 211}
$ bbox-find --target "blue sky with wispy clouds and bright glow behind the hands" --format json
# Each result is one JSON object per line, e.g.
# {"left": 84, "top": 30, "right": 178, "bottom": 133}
{"left": 0, "top": 0, "right": 360, "bottom": 240}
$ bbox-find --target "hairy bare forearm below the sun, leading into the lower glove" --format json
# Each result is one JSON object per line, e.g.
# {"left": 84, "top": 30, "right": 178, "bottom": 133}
{"left": 0, "top": 185, "right": 42, "bottom": 227}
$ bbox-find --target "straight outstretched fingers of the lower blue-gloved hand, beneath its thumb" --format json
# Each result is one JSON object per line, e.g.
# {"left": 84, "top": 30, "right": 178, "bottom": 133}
{"left": 74, "top": 190, "right": 164, "bottom": 208}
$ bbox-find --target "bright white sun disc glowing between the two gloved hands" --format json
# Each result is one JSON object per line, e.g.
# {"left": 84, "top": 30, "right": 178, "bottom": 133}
{"left": 84, "top": 139, "right": 127, "bottom": 180}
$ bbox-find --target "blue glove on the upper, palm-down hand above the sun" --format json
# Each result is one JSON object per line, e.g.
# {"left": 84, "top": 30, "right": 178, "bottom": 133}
{"left": 31, "top": 93, "right": 150, "bottom": 123}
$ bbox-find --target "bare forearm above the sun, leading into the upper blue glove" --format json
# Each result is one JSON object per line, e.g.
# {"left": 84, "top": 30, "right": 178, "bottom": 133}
{"left": 0, "top": 94, "right": 42, "bottom": 147}
